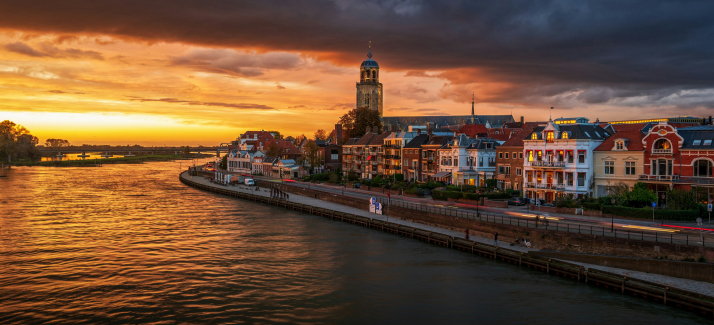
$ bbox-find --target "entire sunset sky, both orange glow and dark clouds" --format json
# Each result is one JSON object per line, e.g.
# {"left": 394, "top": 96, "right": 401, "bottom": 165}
{"left": 0, "top": 0, "right": 714, "bottom": 145}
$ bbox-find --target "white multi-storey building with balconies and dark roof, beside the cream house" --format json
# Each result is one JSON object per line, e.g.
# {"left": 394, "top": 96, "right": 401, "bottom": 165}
{"left": 523, "top": 117, "right": 614, "bottom": 202}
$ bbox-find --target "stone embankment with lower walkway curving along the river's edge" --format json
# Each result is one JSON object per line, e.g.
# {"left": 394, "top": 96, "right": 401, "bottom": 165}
{"left": 180, "top": 172, "right": 714, "bottom": 316}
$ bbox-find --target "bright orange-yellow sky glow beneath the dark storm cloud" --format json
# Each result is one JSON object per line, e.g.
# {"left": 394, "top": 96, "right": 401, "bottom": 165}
{"left": 0, "top": 31, "right": 700, "bottom": 145}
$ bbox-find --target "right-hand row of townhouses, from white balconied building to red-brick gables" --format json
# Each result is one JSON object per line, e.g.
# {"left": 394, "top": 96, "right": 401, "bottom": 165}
{"left": 496, "top": 118, "right": 714, "bottom": 205}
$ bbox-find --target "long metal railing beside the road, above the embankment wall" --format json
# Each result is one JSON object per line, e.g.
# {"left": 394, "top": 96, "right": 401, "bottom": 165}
{"left": 376, "top": 197, "right": 714, "bottom": 247}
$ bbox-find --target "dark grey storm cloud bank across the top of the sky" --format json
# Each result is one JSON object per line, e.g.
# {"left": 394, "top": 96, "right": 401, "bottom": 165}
{"left": 0, "top": 0, "right": 714, "bottom": 107}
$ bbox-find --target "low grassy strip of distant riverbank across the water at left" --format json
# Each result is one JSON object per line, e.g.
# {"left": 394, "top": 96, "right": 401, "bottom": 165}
{"left": 6, "top": 154, "right": 214, "bottom": 167}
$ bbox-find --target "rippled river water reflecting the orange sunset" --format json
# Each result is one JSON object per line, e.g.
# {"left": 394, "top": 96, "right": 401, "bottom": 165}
{"left": 0, "top": 162, "right": 711, "bottom": 324}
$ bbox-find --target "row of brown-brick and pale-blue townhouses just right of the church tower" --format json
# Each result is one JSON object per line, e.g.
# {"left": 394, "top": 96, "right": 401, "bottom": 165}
{"left": 342, "top": 125, "right": 500, "bottom": 185}
